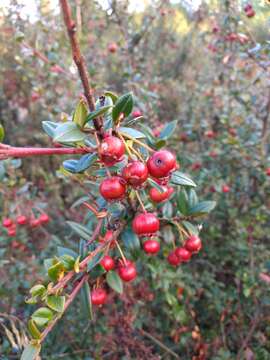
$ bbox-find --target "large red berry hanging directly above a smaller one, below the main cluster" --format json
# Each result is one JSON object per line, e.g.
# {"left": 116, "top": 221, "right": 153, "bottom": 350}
{"left": 132, "top": 213, "right": 159, "bottom": 236}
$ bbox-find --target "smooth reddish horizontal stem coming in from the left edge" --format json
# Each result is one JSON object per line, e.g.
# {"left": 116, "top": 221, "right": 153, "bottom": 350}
{"left": 0, "top": 144, "right": 95, "bottom": 160}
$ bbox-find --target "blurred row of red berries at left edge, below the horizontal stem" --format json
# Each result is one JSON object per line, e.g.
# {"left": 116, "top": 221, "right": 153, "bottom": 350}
{"left": 2, "top": 213, "right": 50, "bottom": 237}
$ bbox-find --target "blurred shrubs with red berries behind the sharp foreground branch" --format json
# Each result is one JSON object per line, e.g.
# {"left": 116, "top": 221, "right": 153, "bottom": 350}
{"left": 0, "top": 0, "right": 270, "bottom": 360}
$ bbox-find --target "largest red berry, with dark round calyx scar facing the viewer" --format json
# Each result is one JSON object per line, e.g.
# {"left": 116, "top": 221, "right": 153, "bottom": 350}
{"left": 147, "top": 150, "right": 176, "bottom": 179}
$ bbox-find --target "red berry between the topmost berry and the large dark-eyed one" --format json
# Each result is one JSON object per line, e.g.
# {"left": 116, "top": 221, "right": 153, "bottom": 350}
{"left": 122, "top": 161, "right": 148, "bottom": 187}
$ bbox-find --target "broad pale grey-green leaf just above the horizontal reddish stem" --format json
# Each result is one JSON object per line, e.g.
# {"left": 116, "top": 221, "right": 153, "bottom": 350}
{"left": 53, "top": 121, "right": 86, "bottom": 143}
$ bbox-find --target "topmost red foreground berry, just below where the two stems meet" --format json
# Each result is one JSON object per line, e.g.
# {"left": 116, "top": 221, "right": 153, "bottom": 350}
{"left": 99, "top": 136, "right": 125, "bottom": 166}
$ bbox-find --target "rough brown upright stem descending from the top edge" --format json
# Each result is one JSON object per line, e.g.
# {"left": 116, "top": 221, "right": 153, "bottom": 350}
{"left": 60, "top": 0, "right": 103, "bottom": 135}
